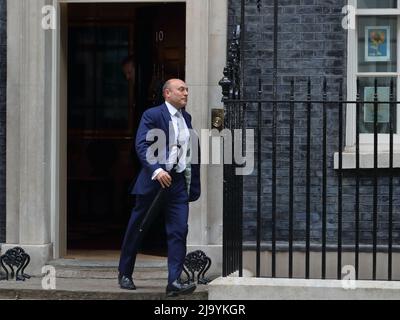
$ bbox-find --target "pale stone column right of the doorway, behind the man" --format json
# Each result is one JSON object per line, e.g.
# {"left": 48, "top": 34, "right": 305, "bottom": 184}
{"left": 186, "top": 0, "right": 228, "bottom": 274}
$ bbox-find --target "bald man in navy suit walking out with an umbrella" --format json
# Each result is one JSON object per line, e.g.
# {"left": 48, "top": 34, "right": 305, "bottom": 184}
{"left": 118, "top": 79, "right": 200, "bottom": 296}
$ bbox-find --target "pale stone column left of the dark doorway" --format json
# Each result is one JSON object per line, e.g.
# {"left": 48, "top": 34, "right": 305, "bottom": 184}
{"left": 2, "top": 0, "right": 52, "bottom": 274}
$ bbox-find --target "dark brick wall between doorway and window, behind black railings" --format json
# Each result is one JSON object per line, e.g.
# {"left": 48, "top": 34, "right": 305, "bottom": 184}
{"left": 229, "top": 0, "right": 400, "bottom": 248}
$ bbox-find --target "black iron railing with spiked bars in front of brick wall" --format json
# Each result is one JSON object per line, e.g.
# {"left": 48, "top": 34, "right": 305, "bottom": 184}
{"left": 221, "top": 74, "right": 400, "bottom": 280}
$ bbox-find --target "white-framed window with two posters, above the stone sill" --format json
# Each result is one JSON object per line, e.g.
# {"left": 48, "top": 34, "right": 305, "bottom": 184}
{"left": 346, "top": 0, "right": 400, "bottom": 152}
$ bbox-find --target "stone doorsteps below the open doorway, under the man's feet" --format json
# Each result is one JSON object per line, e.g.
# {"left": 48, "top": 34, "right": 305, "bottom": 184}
{"left": 0, "top": 256, "right": 208, "bottom": 300}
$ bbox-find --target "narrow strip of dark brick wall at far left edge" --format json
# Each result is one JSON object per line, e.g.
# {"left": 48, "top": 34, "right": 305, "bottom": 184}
{"left": 0, "top": 0, "right": 7, "bottom": 243}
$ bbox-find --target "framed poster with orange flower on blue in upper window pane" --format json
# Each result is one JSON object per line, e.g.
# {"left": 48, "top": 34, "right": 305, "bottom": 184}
{"left": 365, "top": 26, "right": 390, "bottom": 62}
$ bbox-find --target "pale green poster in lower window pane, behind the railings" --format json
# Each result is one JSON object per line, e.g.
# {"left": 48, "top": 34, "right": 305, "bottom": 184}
{"left": 364, "top": 87, "right": 390, "bottom": 123}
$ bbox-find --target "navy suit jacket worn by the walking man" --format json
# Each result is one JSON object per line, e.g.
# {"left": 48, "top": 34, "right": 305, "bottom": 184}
{"left": 131, "top": 103, "right": 200, "bottom": 201}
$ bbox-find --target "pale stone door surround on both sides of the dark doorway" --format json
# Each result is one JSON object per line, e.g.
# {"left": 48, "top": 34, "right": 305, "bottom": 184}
{"left": 1, "top": 0, "right": 228, "bottom": 273}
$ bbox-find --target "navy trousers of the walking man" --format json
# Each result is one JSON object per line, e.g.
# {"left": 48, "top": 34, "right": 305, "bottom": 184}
{"left": 118, "top": 173, "right": 189, "bottom": 284}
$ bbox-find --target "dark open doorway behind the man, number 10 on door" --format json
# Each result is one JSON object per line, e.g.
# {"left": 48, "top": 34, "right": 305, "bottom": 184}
{"left": 67, "top": 3, "right": 186, "bottom": 255}
